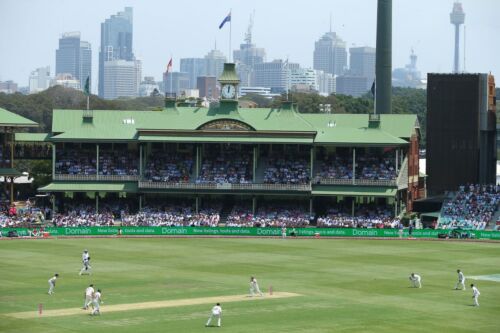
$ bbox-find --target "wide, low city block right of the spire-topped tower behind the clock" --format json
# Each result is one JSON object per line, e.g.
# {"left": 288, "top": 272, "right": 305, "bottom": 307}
{"left": 254, "top": 59, "right": 300, "bottom": 93}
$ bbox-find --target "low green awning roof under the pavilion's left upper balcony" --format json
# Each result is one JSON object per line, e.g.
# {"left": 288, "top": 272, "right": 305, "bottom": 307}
{"left": 38, "top": 182, "right": 137, "bottom": 193}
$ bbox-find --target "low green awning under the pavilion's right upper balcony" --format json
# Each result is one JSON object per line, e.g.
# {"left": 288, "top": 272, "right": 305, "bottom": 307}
{"left": 312, "top": 185, "right": 398, "bottom": 198}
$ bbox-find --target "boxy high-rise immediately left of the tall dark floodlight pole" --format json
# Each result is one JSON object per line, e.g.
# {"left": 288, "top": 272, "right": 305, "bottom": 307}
{"left": 349, "top": 46, "right": 375, "bottom": 89}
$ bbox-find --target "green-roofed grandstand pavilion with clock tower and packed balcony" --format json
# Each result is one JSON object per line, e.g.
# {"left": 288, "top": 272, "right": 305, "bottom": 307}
{"left": 16, "top": 64, "right": 424, "bottom": 222}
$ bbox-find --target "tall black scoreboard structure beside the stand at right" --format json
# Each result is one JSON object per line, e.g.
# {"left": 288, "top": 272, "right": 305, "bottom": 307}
{"left": 426, "top": 73, "right": 496, "bottom": 195}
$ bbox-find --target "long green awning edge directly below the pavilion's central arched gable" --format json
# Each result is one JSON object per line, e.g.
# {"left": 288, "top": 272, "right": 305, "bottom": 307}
{"left": 135, "top": 135, "right": 313, "bottom": 144}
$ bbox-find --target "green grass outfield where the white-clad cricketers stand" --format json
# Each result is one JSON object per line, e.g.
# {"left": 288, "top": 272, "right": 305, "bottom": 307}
{"left": 0, "top": 238, "right": 500, "bottom": 333}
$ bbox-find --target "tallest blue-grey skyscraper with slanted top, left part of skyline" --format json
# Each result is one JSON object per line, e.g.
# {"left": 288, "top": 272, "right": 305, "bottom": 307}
{"left": 99, "top": 7, "right": 135, "bottom": 97}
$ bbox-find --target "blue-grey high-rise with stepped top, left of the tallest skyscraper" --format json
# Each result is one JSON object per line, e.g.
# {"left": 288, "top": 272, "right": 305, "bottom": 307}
{"left": 56, "top": 32, "right": 92, "bottom": 88}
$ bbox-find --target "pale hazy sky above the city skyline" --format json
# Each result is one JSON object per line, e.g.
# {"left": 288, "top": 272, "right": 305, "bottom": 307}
{"left": 0, "top": 0, "right": 500, "bottom": 92}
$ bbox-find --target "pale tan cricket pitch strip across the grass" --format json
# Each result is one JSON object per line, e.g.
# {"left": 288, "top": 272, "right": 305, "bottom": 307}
{"left": 5, "top": 292, "right": 301, "bottom": 319}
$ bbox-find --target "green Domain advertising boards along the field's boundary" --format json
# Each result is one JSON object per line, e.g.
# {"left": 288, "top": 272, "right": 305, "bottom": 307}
{"left": 0, "top": 226, "right": 500, "bottom": 240}
